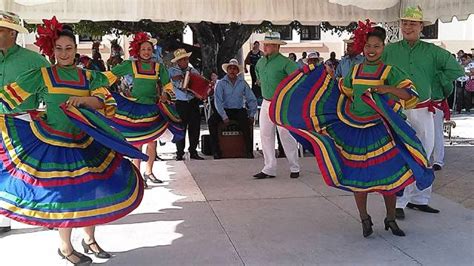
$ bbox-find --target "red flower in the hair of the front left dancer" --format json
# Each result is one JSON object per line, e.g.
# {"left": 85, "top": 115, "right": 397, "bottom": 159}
{"left": 35, "top": 16, "right": 63, "bottom": 58}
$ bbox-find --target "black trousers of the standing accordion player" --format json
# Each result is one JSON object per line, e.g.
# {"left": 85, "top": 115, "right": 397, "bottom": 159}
{"left": 176, "top": 98, "right": 201, "bottom": 156}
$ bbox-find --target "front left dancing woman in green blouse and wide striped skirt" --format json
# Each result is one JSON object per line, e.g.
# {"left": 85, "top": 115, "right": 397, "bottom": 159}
{"left": 0, "top": 18, "right": 146, "bottom": 265}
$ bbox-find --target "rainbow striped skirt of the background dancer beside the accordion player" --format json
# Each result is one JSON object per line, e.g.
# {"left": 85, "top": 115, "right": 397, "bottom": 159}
{"left": 103, "top": 93, "right": 184, "bottom": 145}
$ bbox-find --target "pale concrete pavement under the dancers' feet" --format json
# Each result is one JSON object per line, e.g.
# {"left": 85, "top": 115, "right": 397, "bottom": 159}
{"left": 0, "top": 152, "right": 474, "bottom": 265}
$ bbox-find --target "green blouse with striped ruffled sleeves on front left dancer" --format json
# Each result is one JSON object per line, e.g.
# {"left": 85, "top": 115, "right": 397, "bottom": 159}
{"left": 0, "top": 66, "right": 116, "bottom": 133}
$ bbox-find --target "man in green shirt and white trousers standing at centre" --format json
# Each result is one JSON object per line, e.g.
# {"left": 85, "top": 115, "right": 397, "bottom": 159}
{"left": 254, "top": 32, "right": 300, "bottom": 179}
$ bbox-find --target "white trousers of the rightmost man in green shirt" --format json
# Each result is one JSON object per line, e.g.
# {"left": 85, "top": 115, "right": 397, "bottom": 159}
{"left": 397, "top": 107, "right": 434, "bottom": 208}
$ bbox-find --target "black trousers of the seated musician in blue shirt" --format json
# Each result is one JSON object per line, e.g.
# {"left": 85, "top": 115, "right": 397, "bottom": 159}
{"left": 207, "top": 108, "right": 253, "bottom": 153}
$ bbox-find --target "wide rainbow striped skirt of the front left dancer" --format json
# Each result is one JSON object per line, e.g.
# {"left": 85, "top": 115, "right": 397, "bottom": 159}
{"left": 0, "top": 115, "right": 143, "bottom": 227}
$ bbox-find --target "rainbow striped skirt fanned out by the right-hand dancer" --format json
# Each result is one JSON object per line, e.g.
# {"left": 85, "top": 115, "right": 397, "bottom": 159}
{"left": 270, "top": 66, "right": 434, "bottom": 194}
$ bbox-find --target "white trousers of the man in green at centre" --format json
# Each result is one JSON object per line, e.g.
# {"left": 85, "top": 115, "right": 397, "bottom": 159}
{"left": 258, "top": 100, "right": 300, "bottom": 175}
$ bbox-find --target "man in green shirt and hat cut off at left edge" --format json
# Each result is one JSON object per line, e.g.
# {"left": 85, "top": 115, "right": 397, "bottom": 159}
{"left": 0, "top": 10, "right": 49, "bottom": 233}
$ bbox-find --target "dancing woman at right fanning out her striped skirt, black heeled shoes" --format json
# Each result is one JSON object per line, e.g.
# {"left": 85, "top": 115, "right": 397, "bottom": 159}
{"left": 270, "top": 22, "right": 434, "bottom": 237}
